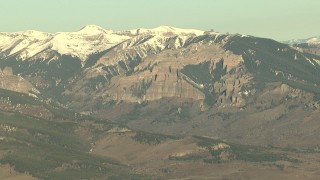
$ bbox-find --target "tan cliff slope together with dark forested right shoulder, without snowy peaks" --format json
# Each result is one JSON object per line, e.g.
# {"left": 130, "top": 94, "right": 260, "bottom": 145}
{"left": 65, "top": 34, "right": 319, "bottom": 112}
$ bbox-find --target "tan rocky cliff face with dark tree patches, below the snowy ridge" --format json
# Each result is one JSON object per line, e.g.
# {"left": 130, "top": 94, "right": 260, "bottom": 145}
{"left": 65, "top": 35, "right": 252, "bottom": 109}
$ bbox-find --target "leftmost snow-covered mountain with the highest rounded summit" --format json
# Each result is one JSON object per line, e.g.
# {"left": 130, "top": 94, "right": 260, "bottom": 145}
{"left": 0, "top": 25, "right": 134, "bottom": 62}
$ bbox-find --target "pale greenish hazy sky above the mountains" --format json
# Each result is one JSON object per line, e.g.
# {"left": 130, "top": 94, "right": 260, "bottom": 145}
{"left": 0, "top": 0, "right": 320, "bottom": 40}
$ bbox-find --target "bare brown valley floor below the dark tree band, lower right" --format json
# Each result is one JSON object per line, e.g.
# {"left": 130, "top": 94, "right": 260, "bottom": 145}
{"left": 92, "top": 132, "right": 320, "bottom": 180}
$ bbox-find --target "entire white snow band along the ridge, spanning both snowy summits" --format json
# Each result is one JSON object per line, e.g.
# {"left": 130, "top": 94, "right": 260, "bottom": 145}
{"left": 0, "top": 25, "right": 205, "bottom": 63}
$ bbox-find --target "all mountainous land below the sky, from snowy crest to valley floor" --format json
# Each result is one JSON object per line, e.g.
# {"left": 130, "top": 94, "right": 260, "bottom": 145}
{"left": 0, "top": 25, "right": 320, "bottom": 179}
